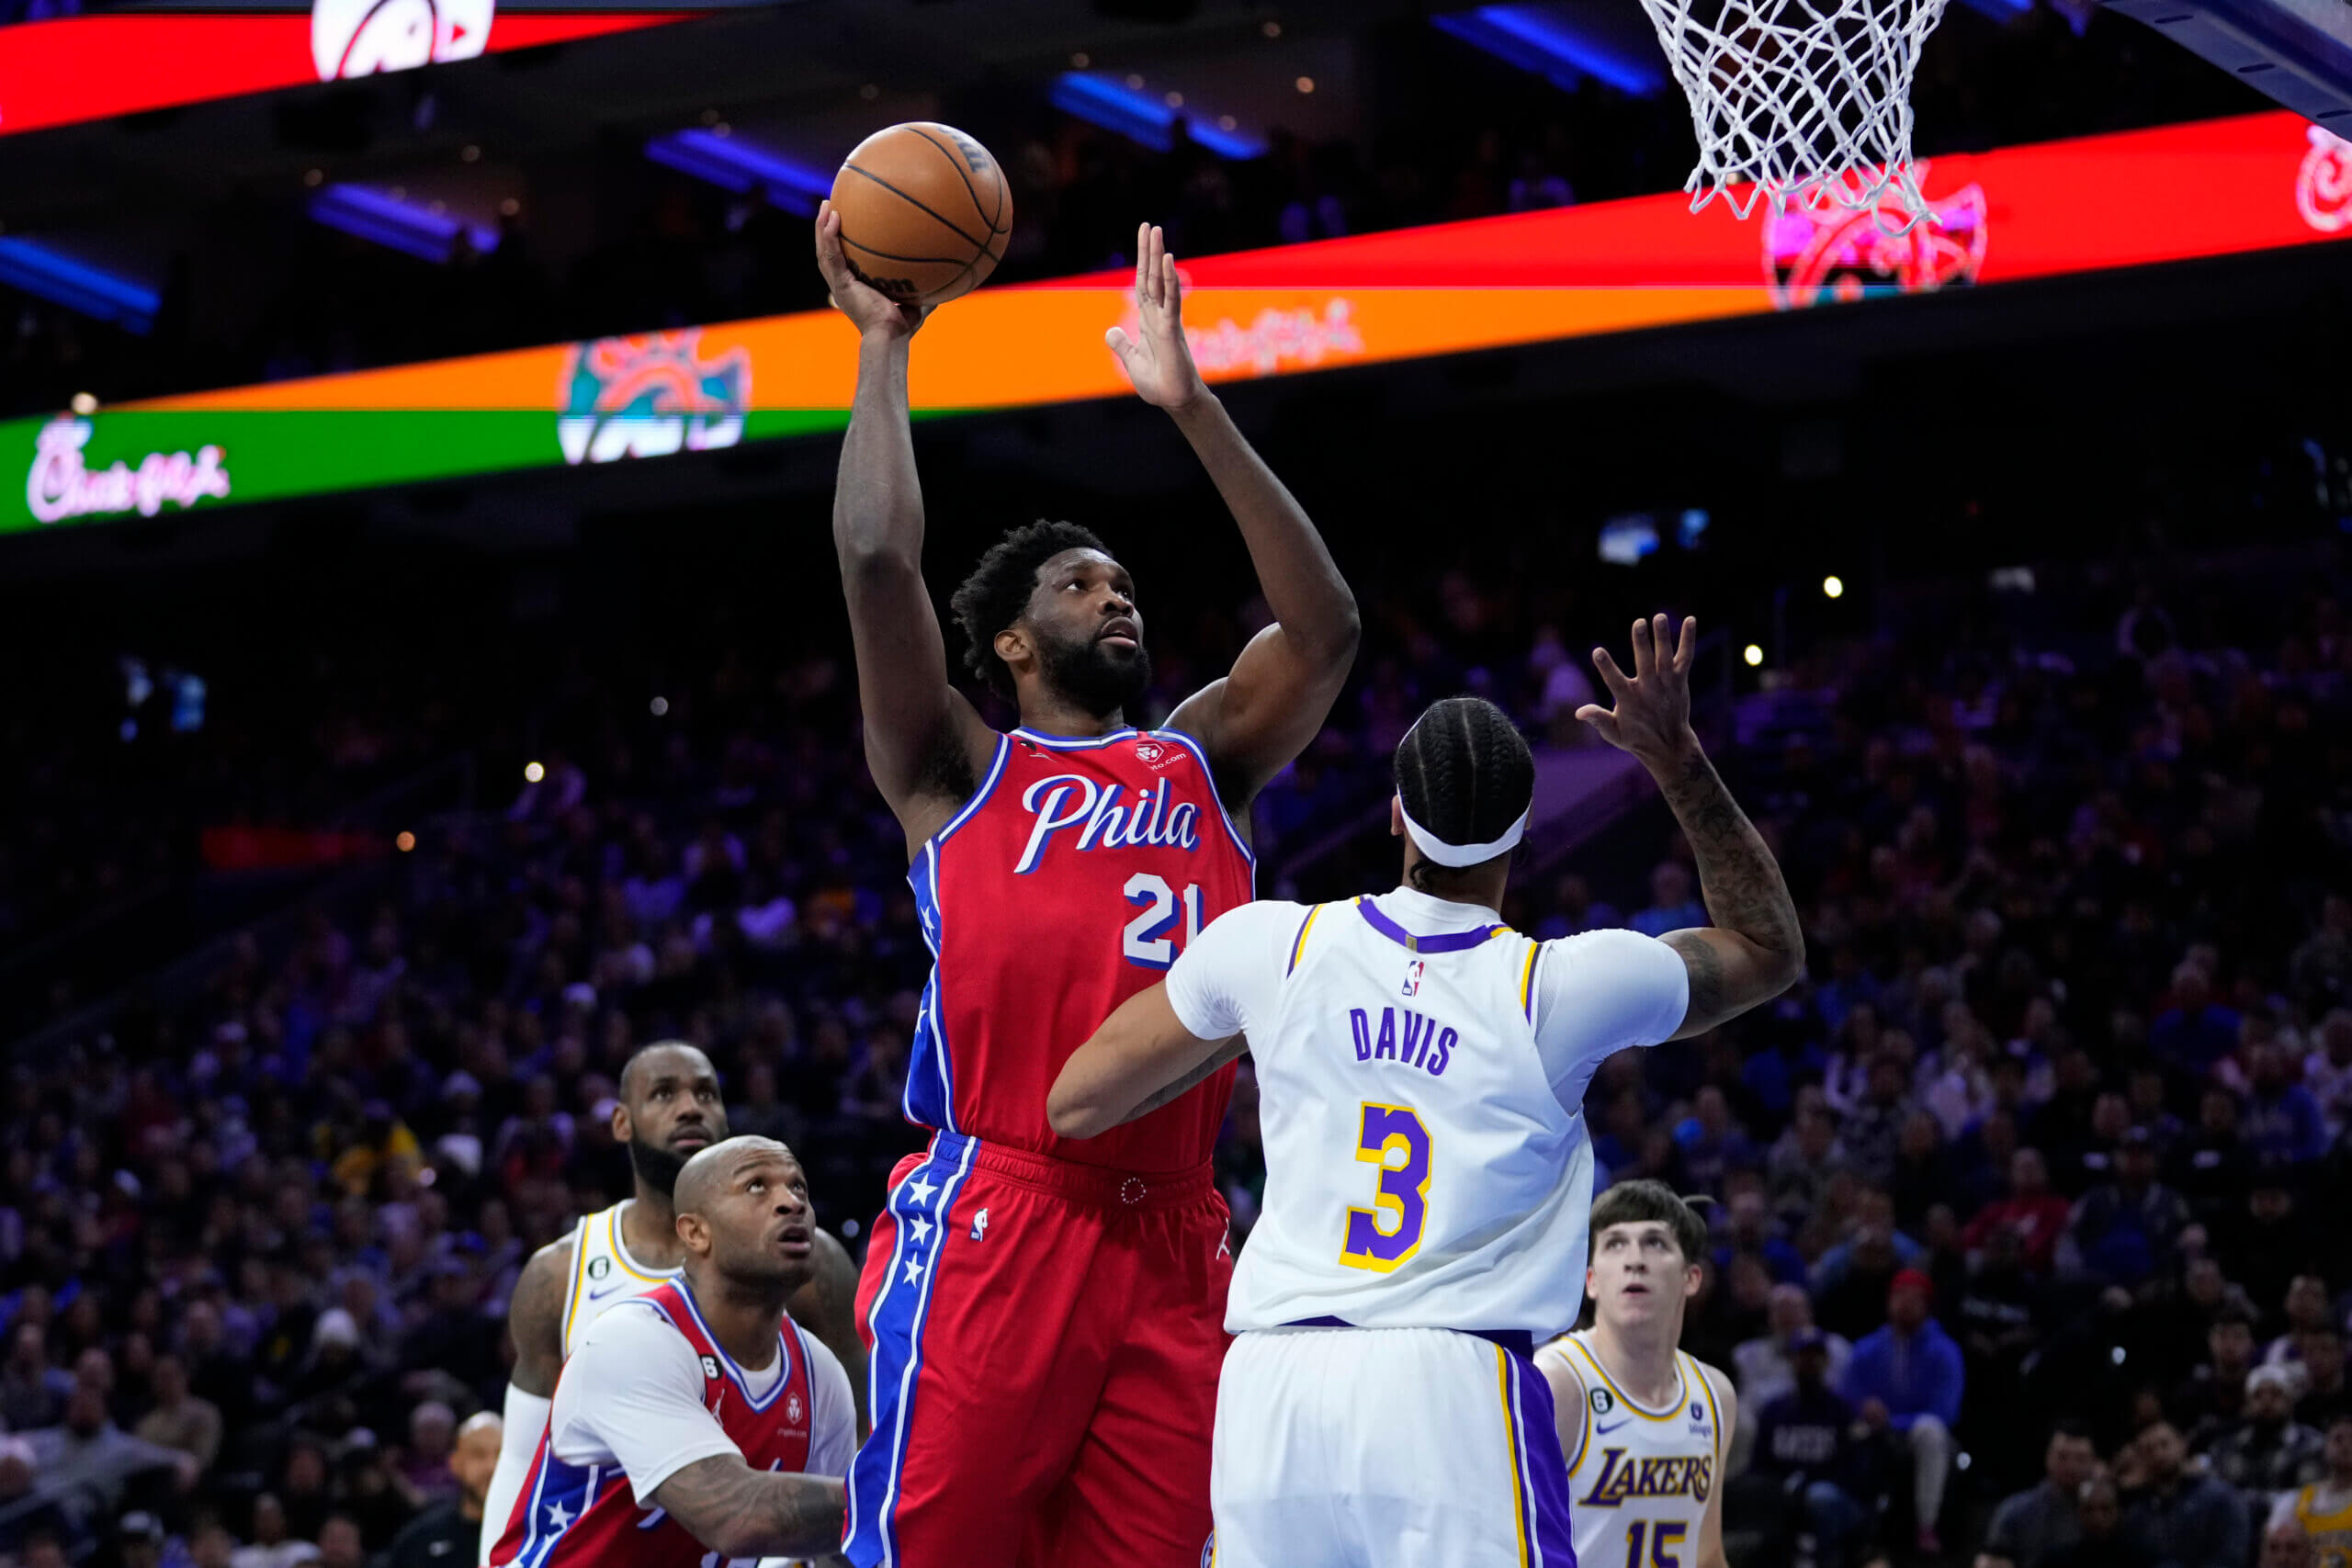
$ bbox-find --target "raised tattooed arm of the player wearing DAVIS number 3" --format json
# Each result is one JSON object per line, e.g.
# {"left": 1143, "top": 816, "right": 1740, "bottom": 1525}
{"left": 1576, "top": 616, "right": 1804, "bottom": 1039}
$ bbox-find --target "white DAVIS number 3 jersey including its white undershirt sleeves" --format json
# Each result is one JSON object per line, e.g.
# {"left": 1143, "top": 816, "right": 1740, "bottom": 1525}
{"left": 1169, "top": 888, "right": 1689, "bottom": 1340}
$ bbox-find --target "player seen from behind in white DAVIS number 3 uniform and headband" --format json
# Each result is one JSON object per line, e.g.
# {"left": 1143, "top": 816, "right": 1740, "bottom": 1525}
{"left": 1049, "top": 616, "right": 1804, "bottom": 1568}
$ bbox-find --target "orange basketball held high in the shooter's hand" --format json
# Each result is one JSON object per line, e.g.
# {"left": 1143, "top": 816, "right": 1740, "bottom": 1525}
{"left": 832, "top": 120, "right": 1013, "bottom": 306}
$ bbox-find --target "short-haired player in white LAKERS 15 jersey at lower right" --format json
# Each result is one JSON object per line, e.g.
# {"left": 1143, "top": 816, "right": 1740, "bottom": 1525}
{"left": 1536, "top": 1180, "right": 1738, "bottom": 1568}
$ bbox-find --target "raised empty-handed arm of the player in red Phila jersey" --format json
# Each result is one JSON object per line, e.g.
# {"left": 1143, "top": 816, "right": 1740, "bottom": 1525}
{"left": 1110, "top": 223, "right": 1357, "bottom": 811}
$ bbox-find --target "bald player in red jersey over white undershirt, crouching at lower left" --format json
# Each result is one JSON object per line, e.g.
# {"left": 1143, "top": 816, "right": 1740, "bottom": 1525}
{"left": 489, "top": 1138, "right": 856, "bottom": 1568}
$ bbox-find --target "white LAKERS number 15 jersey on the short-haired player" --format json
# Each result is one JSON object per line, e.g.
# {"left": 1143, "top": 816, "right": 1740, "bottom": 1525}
{"left": 1536, "top": 1331, "right": 1726, "bottom": 1568}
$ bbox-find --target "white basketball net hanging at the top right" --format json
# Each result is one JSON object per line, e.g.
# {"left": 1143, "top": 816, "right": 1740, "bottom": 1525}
{"left": 1642, "top": 0, "right": 1945, "bottom": 232}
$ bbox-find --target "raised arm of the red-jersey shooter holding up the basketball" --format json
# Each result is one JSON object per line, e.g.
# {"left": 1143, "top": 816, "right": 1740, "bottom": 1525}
{"left": 816, "top": 202, "right": 995, "bottom": 844}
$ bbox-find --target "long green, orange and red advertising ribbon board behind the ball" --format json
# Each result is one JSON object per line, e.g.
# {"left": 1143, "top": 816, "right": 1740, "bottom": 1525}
{"left": 0, "top": 113, "right": 2352, "bottom": 531}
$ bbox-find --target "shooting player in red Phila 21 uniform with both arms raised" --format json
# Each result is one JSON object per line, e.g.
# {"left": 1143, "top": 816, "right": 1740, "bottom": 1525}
{"left": 816, "top": 207, "right": 1357, "bottom": 1568}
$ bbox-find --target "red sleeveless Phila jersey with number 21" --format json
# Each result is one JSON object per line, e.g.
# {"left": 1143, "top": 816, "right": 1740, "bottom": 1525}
{"left": 906, "top": 728, "right": 1251, "bottom": 1170}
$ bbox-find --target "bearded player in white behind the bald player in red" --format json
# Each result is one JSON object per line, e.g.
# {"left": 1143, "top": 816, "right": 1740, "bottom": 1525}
{"left": 475, "top": 1039, "right": 865, "bottom": 1563}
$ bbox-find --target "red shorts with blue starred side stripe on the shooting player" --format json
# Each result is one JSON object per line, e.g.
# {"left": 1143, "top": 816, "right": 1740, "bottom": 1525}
{"left": 842, "top": 1134, "right": 1232, "bottom": 1568}
